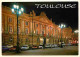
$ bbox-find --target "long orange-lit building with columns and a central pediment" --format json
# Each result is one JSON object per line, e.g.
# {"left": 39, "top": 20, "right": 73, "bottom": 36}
{"left": 2, "top": 6, "right": 72, "bottom": 46}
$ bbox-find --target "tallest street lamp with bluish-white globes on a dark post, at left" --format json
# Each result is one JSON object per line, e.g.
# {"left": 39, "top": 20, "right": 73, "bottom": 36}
{"left": 11, "top": 5, "right": 24, "bottom": 53}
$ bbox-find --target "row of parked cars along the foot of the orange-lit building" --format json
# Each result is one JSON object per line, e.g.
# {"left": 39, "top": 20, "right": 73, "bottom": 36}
{"left": 2, "top": 44, "right": 70, "bottom": 52}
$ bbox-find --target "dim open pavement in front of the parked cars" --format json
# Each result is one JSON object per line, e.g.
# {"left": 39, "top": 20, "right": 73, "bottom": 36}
{"left": 2, "top": 46, "right": 78, "bottom": 56}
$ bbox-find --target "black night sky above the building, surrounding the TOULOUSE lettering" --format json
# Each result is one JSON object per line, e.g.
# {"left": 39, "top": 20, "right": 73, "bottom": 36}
{"left": 2, "top": 2, "right": 78, "bottom": 30}
